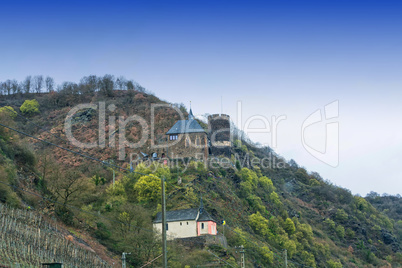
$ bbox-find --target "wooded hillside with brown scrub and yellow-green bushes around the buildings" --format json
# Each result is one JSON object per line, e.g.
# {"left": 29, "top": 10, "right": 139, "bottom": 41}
{"left": 0, "top": 75, "right": 402, "bottom": 268}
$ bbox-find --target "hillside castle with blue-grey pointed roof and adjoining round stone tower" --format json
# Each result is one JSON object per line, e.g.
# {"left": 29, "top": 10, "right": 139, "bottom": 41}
{"left": 164, "top": 108, "right": 231, "bottom": 159}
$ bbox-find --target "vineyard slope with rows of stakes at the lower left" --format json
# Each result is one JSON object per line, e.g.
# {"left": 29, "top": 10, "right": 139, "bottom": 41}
{"left": 0, "top": 204, "right": 111, "bottom": 268}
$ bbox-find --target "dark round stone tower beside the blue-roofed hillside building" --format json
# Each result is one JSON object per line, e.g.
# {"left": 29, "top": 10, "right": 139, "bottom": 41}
{"left": 208, "top": 114, "right": 231, "bottom": 157}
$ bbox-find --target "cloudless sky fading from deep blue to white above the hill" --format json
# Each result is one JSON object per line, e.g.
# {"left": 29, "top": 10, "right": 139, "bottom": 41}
{"left": 0, "top": 0, "right": 402, "bottom": 195}
